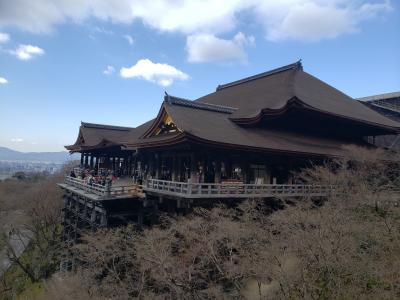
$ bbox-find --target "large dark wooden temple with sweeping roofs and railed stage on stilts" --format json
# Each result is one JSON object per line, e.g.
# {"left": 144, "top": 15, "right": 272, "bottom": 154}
{"left": 60, "top": 62, "right": 400, "bottom": 234}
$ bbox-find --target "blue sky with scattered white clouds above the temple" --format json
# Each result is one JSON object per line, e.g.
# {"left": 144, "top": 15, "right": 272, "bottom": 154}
{"left": 0, "top": 0, "right": 400, "bottom": 151}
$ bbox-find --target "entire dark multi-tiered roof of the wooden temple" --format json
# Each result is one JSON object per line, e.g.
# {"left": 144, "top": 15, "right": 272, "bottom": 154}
{"left": 66, "top": 62, "right": 400, "bottom": 156}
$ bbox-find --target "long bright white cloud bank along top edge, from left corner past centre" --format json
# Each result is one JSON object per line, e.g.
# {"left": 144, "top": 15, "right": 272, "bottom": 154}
{"left": 0, "top": 0, "right": 244, "bottom": 33}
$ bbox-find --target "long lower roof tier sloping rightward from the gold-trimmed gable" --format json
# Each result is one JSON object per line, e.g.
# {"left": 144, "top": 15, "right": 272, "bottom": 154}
{"left": 134, "top": 101, "right": 362, "bottom": 156}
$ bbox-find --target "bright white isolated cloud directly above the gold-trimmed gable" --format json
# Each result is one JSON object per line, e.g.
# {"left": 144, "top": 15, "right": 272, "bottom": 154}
{"left": 120, "top": 59, "right": 189, "bottom": 86}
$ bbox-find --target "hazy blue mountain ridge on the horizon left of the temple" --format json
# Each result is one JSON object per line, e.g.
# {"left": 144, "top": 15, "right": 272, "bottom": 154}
{"left": 0, "top": 147, "right": 80, "bottom": 163}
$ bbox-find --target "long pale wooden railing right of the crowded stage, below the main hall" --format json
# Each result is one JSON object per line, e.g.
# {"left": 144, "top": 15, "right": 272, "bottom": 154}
{"left": 143, "top": 179, "right": 335, "bottom": 198}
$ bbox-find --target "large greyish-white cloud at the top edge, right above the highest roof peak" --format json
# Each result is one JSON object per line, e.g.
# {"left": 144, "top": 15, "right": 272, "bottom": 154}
{"left": 255, "top": 0, "right": 391, "bottom": 41}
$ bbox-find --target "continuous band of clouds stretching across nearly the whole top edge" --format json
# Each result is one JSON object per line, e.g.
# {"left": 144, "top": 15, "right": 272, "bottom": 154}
{"left": 0, "top": 0, "right": 391, "bottom": 41}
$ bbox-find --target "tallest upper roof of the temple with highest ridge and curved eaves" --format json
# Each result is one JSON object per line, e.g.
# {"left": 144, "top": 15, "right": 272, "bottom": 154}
{"left": 196, "top": 62, "right": 400, "bottom": 131}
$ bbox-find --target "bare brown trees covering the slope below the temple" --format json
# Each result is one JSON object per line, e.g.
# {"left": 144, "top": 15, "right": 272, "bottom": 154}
{"left": 0, "top": 149, "right": 400, "bottom": 300}
